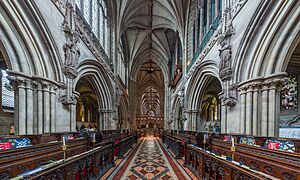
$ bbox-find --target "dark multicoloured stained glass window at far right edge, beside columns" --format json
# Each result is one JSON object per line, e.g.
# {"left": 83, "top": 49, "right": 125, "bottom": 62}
{"left": 281, "top": 74, "right": 298, "bottom": 110}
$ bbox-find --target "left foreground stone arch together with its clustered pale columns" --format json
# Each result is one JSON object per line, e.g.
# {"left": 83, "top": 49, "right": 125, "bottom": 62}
{"left": 0, "top": 1, "right": 68, "bottom": 134}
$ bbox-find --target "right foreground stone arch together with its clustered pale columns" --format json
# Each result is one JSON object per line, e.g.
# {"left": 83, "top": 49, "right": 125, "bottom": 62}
{"left": 231, "top": 1, "right": 300, "bottom": 136}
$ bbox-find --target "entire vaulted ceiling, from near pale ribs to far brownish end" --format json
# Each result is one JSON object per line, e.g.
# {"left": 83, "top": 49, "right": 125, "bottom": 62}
{"left": 115, "top": 0, "right": 190, "bottom": 114}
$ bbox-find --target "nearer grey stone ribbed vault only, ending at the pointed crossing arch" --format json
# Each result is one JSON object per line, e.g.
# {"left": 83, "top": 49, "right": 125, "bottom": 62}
{"left": 116, "top": 0, "right": 189, "bottom": 78}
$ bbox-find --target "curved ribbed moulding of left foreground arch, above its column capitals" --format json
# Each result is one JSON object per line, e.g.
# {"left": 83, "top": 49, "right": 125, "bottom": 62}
{"left": 0, "top": 1, "right": 63, "bottom": 81}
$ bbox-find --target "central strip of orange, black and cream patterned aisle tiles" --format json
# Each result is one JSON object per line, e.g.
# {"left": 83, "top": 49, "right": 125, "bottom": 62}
{"left": 122, "top": 136, "right": 178, "bottom": 180}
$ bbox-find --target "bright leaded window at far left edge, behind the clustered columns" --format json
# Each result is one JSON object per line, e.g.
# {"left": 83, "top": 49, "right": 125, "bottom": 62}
{"left": 2, "top": 70, "right": 14, "bottom": 109}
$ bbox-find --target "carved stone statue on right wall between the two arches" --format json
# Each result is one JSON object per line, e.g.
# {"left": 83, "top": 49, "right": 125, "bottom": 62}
{"left": 219, "top": 36, "right": 231, "bottom": 71}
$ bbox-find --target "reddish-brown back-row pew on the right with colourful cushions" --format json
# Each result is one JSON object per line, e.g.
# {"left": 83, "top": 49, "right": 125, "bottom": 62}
{"left": 211, "top": 135, "right": 300, "bottom": 180}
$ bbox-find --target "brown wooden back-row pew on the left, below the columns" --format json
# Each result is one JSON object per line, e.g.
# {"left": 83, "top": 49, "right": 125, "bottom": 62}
{"left": 0, "top": 134, "right": 88, "bottom": 179}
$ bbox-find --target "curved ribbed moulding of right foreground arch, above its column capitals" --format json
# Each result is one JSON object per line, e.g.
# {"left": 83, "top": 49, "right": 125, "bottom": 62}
{"left": 233, "top": 1, "right": 300, "bottom": 82}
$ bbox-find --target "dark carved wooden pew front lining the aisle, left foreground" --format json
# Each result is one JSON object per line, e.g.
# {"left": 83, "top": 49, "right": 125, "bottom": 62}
{"left": 12, "top": 144, "right": 114, "bottom": 180}
